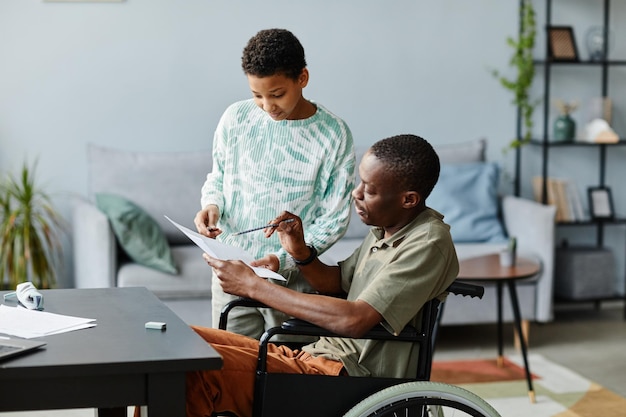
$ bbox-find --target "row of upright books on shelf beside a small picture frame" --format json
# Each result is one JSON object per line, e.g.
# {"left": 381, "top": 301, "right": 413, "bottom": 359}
{"left": 532, "top": 176, "right": 585, "bottom": 222}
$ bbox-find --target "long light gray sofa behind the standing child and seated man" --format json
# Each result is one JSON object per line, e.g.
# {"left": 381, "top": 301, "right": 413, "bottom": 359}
{"left": 72, "top": 140, "right": 554, "bottom": 324}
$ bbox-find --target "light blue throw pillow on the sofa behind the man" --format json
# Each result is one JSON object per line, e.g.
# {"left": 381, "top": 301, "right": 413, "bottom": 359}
{"left": 426, "top": 162, "right": 506, "bottom": 242}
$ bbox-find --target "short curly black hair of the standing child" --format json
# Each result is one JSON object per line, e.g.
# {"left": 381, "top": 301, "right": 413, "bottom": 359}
{"left": 241, "top": 29, "right": 306, "bottom": 80}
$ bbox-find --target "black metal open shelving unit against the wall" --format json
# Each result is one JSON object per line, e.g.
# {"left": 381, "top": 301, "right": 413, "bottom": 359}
{"left": 514, "top": 0, "right": 626, "bottom": 319}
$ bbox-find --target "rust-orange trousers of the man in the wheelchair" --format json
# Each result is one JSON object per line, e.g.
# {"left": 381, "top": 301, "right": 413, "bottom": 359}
{"left": 187, "top": 326, "right": 343, "bottom": 417}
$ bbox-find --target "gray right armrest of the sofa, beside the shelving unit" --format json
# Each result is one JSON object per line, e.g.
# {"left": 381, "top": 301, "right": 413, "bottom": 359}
{"left": 502, "top": 196, "right": 556, "bottom": 322}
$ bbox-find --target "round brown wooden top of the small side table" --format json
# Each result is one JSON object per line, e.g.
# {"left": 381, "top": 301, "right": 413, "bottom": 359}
{"left": 458, "top": 253, "right": 541, "bottom": 281}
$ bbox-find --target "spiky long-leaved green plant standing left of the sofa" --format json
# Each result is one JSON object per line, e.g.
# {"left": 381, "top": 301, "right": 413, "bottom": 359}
{"left": 0, "top": 163, "right": 65, "bottom": 289}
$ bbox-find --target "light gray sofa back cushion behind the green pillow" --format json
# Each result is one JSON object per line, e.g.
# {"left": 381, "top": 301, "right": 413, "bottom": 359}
{"left": 88, "top": 144, "right": 213, "bottom": 244}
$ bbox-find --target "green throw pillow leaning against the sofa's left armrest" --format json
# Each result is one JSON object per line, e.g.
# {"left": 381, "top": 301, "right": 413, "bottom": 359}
{"left": 96, "top": 194, "right": 178, "bottom": 274}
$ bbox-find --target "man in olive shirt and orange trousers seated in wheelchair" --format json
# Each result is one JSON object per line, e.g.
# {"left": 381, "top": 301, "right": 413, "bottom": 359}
{"left": 187, "top": 135, "right": 458, "bottom": 417}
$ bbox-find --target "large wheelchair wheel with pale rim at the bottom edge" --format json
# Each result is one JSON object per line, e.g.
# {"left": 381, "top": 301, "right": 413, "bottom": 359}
{"left": 344, "top": 381, "right": 501, "bottom": 417}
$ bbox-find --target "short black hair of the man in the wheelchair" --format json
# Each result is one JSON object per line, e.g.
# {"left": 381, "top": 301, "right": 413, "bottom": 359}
{"left": 370, "top": 135, "right": 440, "bottom": 200}
